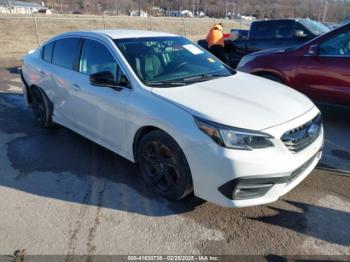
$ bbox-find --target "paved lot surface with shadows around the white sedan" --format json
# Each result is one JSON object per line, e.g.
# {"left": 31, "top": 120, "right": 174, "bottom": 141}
{"left": 0, "top": 60, "right": 350, "bottom": 255}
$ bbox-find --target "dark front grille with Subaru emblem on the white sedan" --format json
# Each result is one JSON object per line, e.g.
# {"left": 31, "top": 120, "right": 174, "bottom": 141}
{"left": 281, "top": 114, "right": 322, "bottom": 153}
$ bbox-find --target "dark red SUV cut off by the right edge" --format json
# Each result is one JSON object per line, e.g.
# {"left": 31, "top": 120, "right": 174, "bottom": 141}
{"left": 237, "top": 24, "right": 350, "bottom": 106}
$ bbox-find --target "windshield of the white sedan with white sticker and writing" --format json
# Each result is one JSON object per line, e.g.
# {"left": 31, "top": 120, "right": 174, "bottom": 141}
{"left": 114, "top": 37, "right": 234, "bottom": 87}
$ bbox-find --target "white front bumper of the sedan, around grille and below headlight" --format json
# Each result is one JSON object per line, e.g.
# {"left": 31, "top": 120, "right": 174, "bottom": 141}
{"left": 185, "top": 107, "right": 323, "bottom": 207}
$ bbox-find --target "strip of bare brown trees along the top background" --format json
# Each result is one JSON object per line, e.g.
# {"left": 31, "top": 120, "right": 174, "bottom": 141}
{"left": 32, "top": 0, "right": 350, "bottom": 22}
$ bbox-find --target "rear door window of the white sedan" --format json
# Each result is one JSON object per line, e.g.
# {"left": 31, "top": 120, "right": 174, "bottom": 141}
{"left": 52, "top": 38, "right": 80, "bottom": 69}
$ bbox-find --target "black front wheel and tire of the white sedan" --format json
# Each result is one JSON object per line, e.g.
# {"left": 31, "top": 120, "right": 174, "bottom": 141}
{"left": 136, "top": 130, "right": 193, "bottom": 200}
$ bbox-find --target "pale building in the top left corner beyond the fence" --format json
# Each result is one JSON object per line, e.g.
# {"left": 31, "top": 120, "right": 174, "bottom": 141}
{"left": 0, "top": 0, "right": 51, "bottom": 14}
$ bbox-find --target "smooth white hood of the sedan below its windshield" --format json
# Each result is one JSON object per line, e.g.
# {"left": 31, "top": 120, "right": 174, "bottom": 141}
{"left": 152, "top": 72, "right": 314, "bottom": 130}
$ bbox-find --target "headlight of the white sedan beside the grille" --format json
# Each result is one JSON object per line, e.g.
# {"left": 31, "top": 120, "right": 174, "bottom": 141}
{"left": 194, "top": 117, "right": 273, "bottom": 150}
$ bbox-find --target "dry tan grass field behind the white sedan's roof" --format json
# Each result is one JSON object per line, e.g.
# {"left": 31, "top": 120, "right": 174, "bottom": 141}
{"left": 0, "top": 15, "right": 246, "bottom": 61}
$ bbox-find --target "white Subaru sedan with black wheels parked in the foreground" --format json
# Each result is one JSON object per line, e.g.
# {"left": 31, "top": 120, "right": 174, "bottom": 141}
{"left": 21, "top": 30, "right": 323, "bottom": 207}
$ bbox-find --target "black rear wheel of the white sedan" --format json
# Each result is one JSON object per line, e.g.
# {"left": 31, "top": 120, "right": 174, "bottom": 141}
{"left": 31, "top": 87, "right": 54, "bottom": 128}
